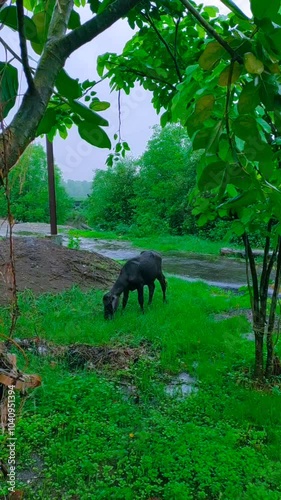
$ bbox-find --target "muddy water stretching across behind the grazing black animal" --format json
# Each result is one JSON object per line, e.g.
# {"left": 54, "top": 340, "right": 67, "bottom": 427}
{"left": 0, "top": 221, "right": 246, "bottom": 290}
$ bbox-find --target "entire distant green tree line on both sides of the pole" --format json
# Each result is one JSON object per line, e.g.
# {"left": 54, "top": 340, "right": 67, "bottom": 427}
{"left": 0, "top": 125, "right": 230, "bottom": 239}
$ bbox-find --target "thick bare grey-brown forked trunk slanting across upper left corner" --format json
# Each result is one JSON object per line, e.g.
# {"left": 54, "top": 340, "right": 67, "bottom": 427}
{"left": 0, "top": 0, "right": 140, "bottom": 177}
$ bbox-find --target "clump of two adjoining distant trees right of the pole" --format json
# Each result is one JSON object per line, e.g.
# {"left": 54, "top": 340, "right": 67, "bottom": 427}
{"left": 84, "top": 125, "right": 228, "bottom": 239}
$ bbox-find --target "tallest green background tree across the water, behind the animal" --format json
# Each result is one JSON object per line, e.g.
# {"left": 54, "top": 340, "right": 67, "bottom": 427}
{"left": 134, "top": 125, "right": 199, "bottom": 235}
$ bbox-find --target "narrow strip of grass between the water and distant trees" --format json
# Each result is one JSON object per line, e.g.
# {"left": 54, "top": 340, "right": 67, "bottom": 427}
{"left": 68, "top": 229, "right": 227, "bottom": 255}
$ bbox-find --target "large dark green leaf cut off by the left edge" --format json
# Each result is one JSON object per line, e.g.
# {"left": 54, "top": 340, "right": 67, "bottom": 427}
{"left": 0, "top": 62, "right": 19, "bottom": 118}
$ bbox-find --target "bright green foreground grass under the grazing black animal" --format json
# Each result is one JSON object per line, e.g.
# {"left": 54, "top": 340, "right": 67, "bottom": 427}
{"left": 0, "top": 278, "right": 281, "bottom": 500}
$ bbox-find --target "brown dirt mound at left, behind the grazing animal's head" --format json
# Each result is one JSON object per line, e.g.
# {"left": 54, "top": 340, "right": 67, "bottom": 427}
{"left": 0, "top": 237, "right": 120, "bottom": 304}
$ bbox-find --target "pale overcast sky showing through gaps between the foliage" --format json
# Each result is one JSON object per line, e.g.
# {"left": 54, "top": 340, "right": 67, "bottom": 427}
{"left": 0, "top": 0, "right": 250, "bottom": 181}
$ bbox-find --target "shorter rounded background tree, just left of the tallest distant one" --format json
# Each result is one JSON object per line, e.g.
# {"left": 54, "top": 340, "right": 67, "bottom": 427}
{"left": 87, "top": 159, "right": 136, "bottom": 230}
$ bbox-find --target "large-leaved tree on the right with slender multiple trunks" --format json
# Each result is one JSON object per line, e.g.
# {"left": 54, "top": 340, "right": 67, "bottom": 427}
{"left": 98, "top": 0, "right": 281, "bottom": 378}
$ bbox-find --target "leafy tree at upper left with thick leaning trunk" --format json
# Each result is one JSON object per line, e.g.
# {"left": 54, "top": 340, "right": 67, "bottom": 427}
{"left": 0, "top": 0, "right": 143, "bottom": 177}
